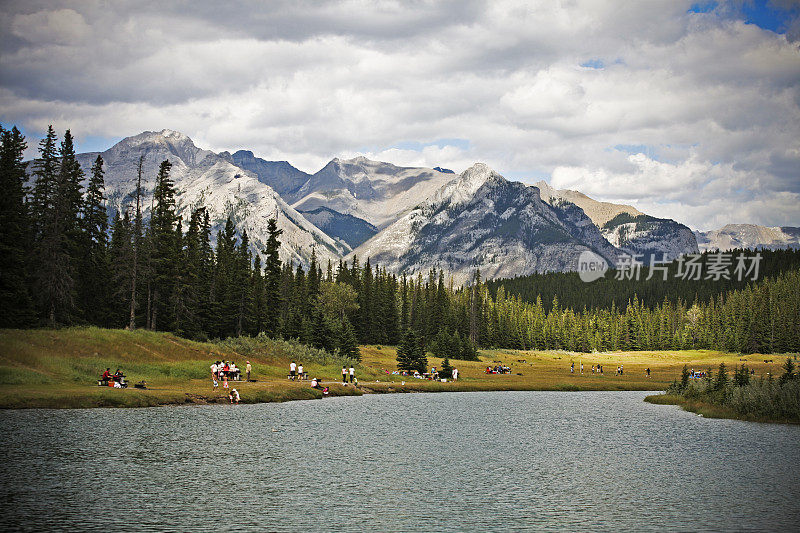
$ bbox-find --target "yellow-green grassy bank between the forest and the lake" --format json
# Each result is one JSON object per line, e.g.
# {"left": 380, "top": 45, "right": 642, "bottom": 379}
{"left": 0, "top": 327, "right": 792, "bottom": 408}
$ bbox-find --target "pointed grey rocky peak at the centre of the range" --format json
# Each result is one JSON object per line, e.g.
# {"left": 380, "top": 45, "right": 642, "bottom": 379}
{"left": 354, "top": 163, "right": 618, "bottom": 282}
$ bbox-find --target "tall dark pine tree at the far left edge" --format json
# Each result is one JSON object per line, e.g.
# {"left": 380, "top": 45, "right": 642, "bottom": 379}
{"left": 0, "top": 126, "right": 36, "bottom": 328}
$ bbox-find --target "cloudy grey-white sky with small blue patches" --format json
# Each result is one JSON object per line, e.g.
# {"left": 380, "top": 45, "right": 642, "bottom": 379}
{"left": 0, "top": 0, "right": 800, "bottom": 230}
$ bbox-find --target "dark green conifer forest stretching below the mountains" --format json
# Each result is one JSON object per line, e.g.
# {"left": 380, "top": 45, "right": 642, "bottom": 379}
{"left": 0, "top": 123, "right": 800, "bottom": 359}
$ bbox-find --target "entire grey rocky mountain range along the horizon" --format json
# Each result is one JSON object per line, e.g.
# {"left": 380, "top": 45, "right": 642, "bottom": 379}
{"left": 59, "top": 130, "right": 800, "bottom": 282}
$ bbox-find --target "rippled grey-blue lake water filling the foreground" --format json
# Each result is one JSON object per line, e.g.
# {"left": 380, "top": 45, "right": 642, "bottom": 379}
{"left": 0, "top": 392, "right": 800, "bottom": 531}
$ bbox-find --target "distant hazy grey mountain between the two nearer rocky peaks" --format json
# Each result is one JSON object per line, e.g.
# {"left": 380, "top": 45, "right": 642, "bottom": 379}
{"left": 292, "top": 157, "right": 453, "bottom": 228}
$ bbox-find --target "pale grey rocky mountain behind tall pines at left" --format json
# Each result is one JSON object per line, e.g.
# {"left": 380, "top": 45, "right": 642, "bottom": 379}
{"left": 78, "top": 130, "right": 350, "bottom": 263}
